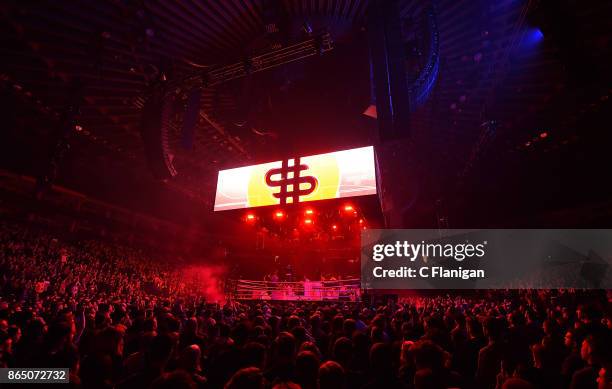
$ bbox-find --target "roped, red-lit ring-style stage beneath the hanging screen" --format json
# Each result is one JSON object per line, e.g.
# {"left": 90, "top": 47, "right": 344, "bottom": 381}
{"left": 228, "top": 279, "right": 361, "bottom": 301}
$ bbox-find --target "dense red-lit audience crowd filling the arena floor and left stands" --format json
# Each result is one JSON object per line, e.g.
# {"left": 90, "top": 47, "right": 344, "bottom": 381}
{"left": 0, "top": 221, "right": 612, "bottom": 389}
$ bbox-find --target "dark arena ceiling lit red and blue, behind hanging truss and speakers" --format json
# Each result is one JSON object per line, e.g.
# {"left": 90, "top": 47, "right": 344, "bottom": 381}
{"left": 0, "top": 0, "right": 612, "bottom": 227}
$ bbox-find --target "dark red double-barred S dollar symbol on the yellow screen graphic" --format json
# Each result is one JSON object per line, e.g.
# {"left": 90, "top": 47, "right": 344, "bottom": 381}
{"left": 266, "top": 158, "right": 318, "bottom": 204}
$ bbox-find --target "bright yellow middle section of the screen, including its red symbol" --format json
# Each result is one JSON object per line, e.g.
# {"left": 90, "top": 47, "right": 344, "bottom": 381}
{"left": 247, "top": 155, "right": 340, "bottom": 207}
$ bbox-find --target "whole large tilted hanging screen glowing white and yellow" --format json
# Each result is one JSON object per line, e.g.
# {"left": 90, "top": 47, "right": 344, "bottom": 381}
{"left": 215, "top": 146, "right": 376, "bottom": 211}
